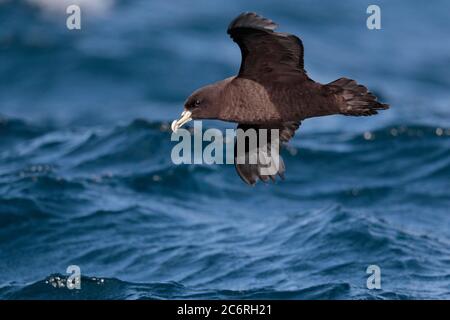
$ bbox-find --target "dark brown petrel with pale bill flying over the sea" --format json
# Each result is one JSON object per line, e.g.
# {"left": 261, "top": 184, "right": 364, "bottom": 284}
{"left": 172, "top": 13, "right": 389, "bottom": 185}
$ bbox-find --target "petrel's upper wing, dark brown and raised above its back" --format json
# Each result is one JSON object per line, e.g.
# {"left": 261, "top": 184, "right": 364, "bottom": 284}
{"left": 227, "top": 12, "right": 306, "bottom": 81}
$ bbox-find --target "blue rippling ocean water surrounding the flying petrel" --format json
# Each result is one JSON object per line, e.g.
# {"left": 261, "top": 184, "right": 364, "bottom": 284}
{"left": 0, "top": 0, "right": 450, "bottom": 299}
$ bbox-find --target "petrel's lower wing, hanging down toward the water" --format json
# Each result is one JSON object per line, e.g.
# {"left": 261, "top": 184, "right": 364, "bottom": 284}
{"left": 234, "top": 122, "right": 300, "bottom": 185}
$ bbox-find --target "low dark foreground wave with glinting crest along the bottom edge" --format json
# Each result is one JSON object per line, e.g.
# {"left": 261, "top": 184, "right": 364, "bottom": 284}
{"left": 0, "top": 274, "right": 350, "bottom": 300}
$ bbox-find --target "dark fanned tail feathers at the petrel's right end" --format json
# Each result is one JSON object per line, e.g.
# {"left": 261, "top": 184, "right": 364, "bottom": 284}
{"left": 328, "top": 78, "right": 389, "bottom": 116}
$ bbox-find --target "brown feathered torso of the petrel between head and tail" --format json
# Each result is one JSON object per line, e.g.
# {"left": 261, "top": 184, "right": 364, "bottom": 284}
{"left": 209, "top": 77, "right": 344, "bottom": 124}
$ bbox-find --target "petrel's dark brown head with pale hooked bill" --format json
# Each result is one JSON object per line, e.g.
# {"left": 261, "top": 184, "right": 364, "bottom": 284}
{"left": 171, "top": 84, "right": 220, "bottom": 132}
